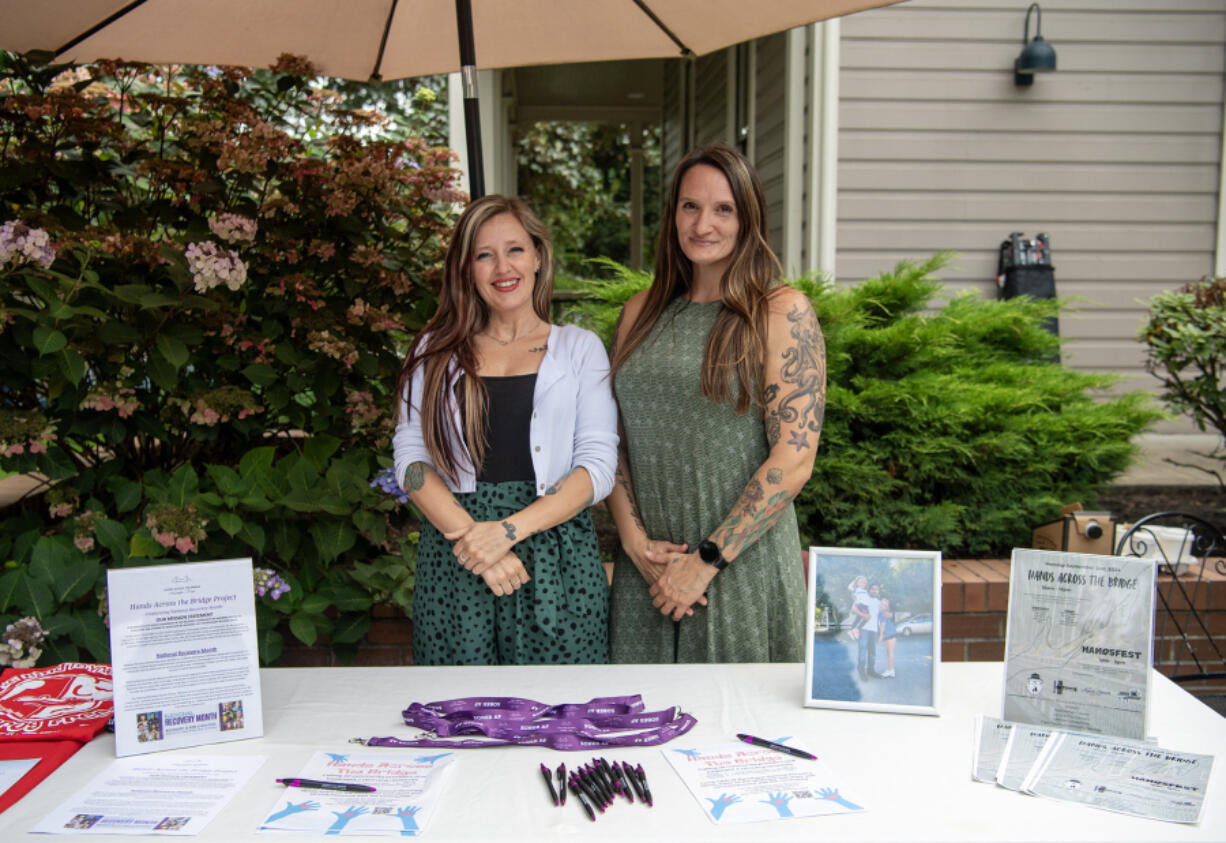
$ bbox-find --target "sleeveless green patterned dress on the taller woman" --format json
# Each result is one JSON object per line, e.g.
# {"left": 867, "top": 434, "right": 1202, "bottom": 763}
{"left": 609, "top": 298, "right": 805, "bottom": 664}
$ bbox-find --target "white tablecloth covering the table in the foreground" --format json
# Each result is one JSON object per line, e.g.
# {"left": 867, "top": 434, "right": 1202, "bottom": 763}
{"left": 0, "top": 662, "right": 1226, "bottom": 843}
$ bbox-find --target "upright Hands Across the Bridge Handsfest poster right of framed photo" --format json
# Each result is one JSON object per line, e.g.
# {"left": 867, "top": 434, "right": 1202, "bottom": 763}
{"left": 1003, "top": 548, "right": 1155, "bottom": 739}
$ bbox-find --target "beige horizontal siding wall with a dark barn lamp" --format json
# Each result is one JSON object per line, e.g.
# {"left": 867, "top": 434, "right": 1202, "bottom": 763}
{"left": 836, "top": 0, "right": 1226, "bottom": 401}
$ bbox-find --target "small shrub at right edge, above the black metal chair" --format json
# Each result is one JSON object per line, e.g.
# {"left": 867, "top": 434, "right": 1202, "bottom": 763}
{"left": 1140, "top": 278, "right": 1226, "bottom": 486}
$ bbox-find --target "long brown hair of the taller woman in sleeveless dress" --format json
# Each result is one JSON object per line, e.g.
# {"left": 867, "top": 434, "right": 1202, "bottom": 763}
{"left": 612, "top": 143, "right": 781, "bottom": 413}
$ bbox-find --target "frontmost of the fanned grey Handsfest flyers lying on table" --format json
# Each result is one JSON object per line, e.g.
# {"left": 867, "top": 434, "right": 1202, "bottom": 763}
{"left": 1022, "top": 733, "right": 1214, "bottom": 822}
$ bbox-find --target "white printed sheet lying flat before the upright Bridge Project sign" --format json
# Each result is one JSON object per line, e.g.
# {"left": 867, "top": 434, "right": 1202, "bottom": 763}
{"left": 31, "top": 755, "right": 265, "bottom": 834}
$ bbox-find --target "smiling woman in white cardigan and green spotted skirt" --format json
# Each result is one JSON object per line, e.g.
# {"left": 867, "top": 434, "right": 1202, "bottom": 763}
{"left": 392, "top": 196, "right": 617, "bottom": 664}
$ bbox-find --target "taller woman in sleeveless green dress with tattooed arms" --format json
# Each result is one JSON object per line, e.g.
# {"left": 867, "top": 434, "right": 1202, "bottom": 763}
{"left": 608, "top": 145, "right": 826, "bottom": 663}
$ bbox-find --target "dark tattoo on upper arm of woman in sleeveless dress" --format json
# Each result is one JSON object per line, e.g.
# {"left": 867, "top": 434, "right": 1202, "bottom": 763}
{"left": 765, "top": 306, "right": 826, "bottom": 451}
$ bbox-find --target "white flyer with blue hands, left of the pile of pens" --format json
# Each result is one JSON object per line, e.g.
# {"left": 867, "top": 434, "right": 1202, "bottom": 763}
{"left": 260, "top": 750, "right": 456, "bottom": 837}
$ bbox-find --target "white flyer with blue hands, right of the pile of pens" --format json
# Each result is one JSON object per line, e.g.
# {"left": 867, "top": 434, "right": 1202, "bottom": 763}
{"left": 661, "top": 738, "right": 864, "bottom": 825}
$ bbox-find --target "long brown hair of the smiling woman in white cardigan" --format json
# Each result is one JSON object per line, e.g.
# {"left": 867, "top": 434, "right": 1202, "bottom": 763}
{"left": 396, "top": 194, "right": 553, "bottom": 482}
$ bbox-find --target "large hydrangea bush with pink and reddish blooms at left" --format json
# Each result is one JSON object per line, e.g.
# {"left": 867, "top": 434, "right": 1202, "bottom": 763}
{"left": 0, "top": 54, "right": 465, "bottom": 663}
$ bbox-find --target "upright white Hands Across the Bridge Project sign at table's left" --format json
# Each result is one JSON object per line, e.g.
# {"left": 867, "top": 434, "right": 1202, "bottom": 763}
{"left": 107, "top": 559, "right": 264, "bottom": 757}
